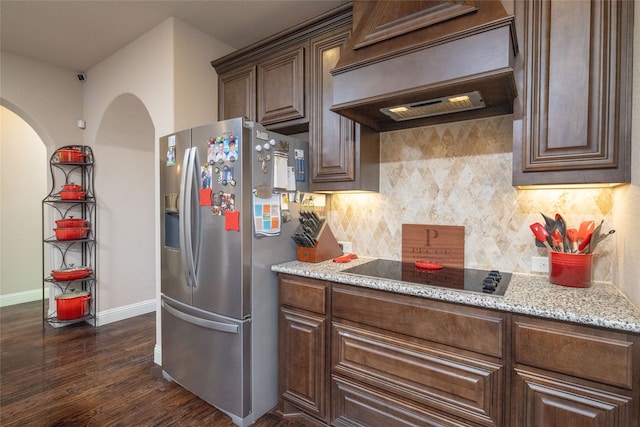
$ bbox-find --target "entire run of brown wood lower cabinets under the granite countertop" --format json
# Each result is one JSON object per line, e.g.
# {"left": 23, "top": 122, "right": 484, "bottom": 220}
{"left": 279, "top": 274, "right": 640, "bottom": 427}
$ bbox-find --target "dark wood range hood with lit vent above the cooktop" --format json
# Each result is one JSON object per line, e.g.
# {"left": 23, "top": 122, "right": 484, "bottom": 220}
{"left": 331, "top": 0, "right": 518, "bottom": 131}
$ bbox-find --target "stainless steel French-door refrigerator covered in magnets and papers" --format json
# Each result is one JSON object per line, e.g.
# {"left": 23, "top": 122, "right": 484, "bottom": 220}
{"left": 160, "top": 118, "right": 308, "bottom": 426}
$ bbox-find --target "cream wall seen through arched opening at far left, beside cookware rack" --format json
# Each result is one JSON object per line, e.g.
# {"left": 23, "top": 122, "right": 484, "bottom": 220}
{"left": 0, "top": 106, "right": 47, "bottom": 306}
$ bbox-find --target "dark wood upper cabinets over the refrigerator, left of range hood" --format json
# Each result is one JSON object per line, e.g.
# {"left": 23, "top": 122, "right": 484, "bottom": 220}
{"left": 211, "top": 4, "right": 380, "bottom": 192}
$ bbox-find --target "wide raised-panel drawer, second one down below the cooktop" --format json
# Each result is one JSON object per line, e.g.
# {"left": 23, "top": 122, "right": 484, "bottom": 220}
{"left": 331, "top": 322, "right": 505, "bottom": 426}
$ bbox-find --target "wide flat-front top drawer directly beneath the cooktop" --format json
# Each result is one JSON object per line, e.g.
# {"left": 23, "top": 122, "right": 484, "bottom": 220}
{"left": 331, "top": 284, "right": 506, "bottom": 358}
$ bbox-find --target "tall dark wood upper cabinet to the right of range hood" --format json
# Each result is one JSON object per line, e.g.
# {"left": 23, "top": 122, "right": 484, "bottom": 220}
{"left": 513, "top": 0, "right": 634, "bottom": 186}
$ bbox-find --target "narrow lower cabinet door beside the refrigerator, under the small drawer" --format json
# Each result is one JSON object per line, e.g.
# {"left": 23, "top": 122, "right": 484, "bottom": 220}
{"left": 279, "top": 307, "right": 328, "bottom": 420}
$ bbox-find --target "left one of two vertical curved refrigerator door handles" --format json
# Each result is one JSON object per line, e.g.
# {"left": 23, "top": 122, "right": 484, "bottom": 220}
{"left": 180, "top": 148, "right": 194, "bottom": 286}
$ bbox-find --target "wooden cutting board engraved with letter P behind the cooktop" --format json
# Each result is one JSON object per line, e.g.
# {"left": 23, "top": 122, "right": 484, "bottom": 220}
{"left": 402, "top": 224, "right": 464, "bottom": 268}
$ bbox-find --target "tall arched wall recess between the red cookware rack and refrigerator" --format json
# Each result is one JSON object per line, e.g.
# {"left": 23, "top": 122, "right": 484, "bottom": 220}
{"left": 94, "top": 94, "right": 156, "bottom": 324}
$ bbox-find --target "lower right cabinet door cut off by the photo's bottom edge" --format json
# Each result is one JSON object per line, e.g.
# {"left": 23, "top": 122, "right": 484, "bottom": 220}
{"left": 512, "top": 369, "right": 635, "bottom": 427}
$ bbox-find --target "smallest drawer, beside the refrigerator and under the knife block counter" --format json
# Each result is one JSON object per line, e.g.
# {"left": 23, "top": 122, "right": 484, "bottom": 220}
{"left": 280, "top": 274, "right": 327, "bottom": 314}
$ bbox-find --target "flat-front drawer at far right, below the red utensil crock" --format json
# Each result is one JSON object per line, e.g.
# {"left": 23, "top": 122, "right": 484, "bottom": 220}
{"left": 513, "top": 317, "right": 638, "bottom": 389}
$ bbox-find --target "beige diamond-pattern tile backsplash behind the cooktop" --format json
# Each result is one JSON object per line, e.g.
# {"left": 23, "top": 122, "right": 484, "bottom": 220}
{"left": 328, "top": 115, "right": 615, "bottom": 281}
